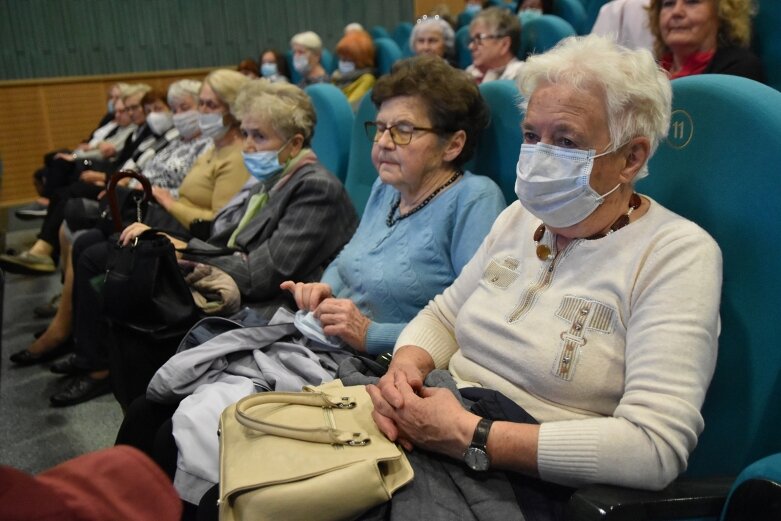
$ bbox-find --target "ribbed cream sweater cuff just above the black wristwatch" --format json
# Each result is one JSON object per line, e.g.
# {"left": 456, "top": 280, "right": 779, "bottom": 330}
{"left": 537, "top": 421, "right": 599, "bottom": 486}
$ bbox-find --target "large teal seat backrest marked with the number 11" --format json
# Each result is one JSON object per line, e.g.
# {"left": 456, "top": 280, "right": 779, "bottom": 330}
{"left": 638, "top": 74, "right": 781, "bottom": 476}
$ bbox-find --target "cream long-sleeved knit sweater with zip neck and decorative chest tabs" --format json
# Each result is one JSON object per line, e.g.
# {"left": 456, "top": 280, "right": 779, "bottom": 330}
{"left": 396, "top": 197, "right": 721, "bottom": 489}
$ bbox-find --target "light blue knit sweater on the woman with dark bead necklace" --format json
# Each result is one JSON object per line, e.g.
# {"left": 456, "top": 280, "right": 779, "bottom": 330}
{"left": 322, "top": 172, "right": 506, "bottom": 354}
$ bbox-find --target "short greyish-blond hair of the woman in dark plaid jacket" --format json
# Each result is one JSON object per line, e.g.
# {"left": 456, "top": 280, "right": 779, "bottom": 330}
{"left": 231, "top": 78, "right": 317, "bottom": 146}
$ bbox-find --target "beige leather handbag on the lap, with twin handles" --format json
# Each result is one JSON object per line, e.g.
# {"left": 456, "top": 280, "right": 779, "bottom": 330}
{"left": 220, "top": 380, "right": 413, "bottom": 521}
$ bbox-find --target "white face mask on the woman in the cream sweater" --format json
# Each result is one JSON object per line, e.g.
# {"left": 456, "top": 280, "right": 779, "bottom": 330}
{"left": 515, "top": 143, "right": 621, "bottom": 228}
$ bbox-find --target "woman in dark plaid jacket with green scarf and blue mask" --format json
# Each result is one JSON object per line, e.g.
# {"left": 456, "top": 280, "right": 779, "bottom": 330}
{"left": 45, "top": 80, "right": 357, "bottom": 406}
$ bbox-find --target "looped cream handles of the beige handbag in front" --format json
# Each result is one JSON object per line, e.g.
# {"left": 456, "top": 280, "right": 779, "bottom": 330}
{"left": 236, "top": 386, "right": 370, "bottom": 446}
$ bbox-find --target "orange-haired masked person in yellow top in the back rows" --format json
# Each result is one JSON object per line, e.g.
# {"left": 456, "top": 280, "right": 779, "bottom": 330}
{"left": 331, "top": 31, "right": 376, "bottom": 108}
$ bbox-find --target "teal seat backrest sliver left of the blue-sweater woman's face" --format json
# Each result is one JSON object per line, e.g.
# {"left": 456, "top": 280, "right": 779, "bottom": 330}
{"left": 344, "top": 91, "right": 378, "bottom": 216}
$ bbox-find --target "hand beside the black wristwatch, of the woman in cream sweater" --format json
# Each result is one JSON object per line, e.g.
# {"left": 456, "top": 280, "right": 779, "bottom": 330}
{"left": 366, "top": 379, "right": 480, "bottom": 459}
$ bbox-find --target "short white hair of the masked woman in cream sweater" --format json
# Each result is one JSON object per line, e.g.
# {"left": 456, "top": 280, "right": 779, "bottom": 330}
{"left": 518, "top": 34, "right": 672, "bottom": 171}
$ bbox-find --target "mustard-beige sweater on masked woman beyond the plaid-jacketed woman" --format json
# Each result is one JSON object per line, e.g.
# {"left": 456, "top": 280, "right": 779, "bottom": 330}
{"left": 168, "top": 140, "right": 249, "bottom": 228}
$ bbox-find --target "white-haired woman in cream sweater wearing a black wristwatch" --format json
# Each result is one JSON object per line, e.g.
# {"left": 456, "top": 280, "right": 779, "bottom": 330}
{"left": 368, "top": 36, "right": 721, "bottom": 519}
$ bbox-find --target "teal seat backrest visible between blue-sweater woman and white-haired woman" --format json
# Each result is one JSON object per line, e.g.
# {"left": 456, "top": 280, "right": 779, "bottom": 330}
{"left": 465, "top": 80, "right": 523, "bottom": 204}
